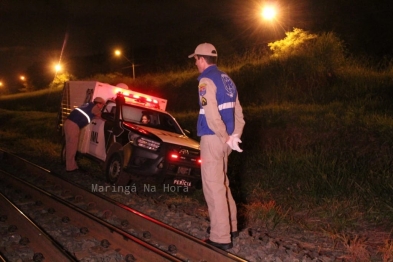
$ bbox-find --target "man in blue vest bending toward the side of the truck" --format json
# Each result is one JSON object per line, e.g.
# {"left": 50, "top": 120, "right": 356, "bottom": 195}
{"left": 64, "top": 97, "right": 105, "bottom": 172}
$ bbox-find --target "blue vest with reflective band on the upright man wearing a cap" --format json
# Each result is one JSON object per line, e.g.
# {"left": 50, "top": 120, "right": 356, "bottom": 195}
{"left": 197, "top": 65, "right": 237, "bottom": 136}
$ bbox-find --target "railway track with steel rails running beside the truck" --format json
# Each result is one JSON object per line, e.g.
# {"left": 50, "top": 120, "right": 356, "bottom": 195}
{"left": 0, "top": 150, "right": 246, "bottom": 262}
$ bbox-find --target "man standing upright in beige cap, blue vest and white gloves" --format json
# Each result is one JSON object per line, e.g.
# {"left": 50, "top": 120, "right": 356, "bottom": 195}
{"left": 188, "top": 43, "right": 245, "bottom": 250}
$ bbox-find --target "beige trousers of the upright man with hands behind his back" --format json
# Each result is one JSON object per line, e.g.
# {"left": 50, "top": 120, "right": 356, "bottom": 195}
{"left": 200, "top": 135, "right": 237, "bottom": 243}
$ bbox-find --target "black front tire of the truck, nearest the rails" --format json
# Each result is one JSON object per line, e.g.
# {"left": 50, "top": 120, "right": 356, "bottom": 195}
{"left": 106, "top": 153, "right": 130, "bottom": 186}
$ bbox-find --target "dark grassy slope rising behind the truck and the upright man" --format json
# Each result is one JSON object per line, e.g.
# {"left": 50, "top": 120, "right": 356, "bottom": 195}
{"left": 0, "top": 32, "right": 393, "bottom": 258}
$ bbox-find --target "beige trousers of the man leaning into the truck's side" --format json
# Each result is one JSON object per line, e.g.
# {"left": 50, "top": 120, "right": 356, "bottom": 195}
{"left": 64, "top": 119, "right": 80, "bottom": 171}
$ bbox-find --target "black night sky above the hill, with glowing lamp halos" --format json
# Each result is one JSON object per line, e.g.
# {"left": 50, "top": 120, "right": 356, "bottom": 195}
{"left": 0, "top": 0, "right": 393, "bottom": 90}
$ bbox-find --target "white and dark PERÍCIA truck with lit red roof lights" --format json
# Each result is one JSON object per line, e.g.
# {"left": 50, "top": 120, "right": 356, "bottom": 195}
{"left": 58, "top": 81, "right": 201, "bottom": 188}
